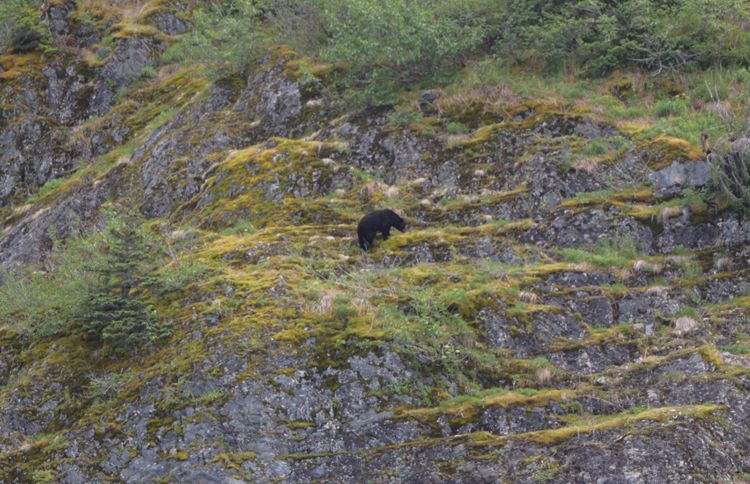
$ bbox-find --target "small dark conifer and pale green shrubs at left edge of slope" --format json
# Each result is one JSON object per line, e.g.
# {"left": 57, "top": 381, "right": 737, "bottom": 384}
{"left": 0, "top": 210, "right": 173, "bottom": 352}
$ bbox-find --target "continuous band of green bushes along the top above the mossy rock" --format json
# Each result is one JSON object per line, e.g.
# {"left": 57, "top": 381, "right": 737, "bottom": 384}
{"left": 164, "top": 0, "right": 750, "bottom": 105}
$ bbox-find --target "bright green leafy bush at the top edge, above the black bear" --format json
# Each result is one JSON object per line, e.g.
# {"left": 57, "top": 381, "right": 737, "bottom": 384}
{"left": 321, "top": 0, "right": 482, "bottom": 105}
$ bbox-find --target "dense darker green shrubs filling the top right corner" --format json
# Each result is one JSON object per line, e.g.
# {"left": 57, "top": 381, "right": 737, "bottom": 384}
{"left": 508, "top": 0, "right": 750, "bottom": 76}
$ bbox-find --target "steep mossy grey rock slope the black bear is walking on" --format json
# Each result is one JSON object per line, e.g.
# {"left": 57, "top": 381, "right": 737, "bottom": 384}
{"left": 0, "top": 0, "right": 750, "bottom": 482}
